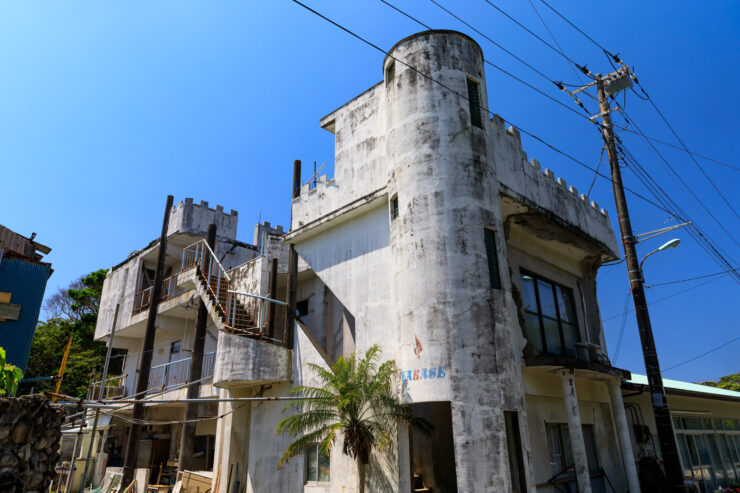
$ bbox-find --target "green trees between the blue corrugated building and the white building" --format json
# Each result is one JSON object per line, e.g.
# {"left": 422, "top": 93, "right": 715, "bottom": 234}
{"left": 24, "top": 269, "right": 122, "bottom": 397}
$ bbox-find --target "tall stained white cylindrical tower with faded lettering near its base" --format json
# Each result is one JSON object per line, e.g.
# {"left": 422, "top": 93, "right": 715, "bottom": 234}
{"left": 383, "top": 31, "right": 521, "bottom": 491}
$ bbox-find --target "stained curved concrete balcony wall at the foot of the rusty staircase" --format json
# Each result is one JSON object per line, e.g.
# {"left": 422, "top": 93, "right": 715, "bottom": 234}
{"left": 213, "top": 331, "right": 293, "bottom": 388}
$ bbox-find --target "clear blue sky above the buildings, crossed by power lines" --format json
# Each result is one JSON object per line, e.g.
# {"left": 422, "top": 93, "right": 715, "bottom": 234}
{"left": 0, "top": 0, "right": 740, "bottom": 381}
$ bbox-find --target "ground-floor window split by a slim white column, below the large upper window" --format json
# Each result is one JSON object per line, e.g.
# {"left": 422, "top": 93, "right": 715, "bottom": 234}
{"left": 546, "top": 423, "right": 606, "bottom": 493}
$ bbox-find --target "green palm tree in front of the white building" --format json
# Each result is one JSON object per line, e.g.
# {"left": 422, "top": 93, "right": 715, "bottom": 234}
{"left": 277, "top": 345, "right": 430, "bottom": 493}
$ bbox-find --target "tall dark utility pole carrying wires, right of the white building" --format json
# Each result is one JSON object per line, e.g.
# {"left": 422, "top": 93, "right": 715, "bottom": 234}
{"left": 596, "top": 73, "right": 685, "bottom": 492}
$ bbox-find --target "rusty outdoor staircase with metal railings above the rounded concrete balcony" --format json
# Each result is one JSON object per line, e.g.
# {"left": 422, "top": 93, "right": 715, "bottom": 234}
{"left": 182, "top": 240, "right": 286, "bottom": 346}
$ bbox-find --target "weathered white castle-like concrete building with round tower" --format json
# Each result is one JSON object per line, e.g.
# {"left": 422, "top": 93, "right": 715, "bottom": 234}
{"left": 86, "top": 31, "right": 740, "bottom": 493}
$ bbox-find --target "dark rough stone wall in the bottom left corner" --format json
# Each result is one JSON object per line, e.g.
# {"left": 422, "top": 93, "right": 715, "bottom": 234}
{"left": 0, "top": 394, "right": 63, "bottom": 493}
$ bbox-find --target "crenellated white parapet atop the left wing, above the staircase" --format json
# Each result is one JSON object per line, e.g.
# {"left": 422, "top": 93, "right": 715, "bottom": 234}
{"left": 167, "top": 197, "right": 239, "bottom": 240}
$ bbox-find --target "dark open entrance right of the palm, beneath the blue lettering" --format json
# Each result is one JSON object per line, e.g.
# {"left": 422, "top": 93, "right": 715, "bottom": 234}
{"left": 410, "top": 402, "right": 457, "bottom": 493}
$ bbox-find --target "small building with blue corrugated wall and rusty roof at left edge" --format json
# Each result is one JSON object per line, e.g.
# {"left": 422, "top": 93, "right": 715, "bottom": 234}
{"left": 0, "top": 225, "right": 53, "bottom": 371}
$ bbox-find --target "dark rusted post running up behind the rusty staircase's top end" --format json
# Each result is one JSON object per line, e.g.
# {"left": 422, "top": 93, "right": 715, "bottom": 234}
{"left": 177, "top": 224, "right": 216, "bottom": 472}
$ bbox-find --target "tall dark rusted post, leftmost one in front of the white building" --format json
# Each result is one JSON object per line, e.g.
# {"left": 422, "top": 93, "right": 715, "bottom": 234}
{"left": 122, "top": 195, "right": 174, "bottom": 488}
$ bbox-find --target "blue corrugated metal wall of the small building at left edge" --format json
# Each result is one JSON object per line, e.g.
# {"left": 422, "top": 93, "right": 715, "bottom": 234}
{"left": 0, "top": 258, "right": 51, "bottom": 371}
